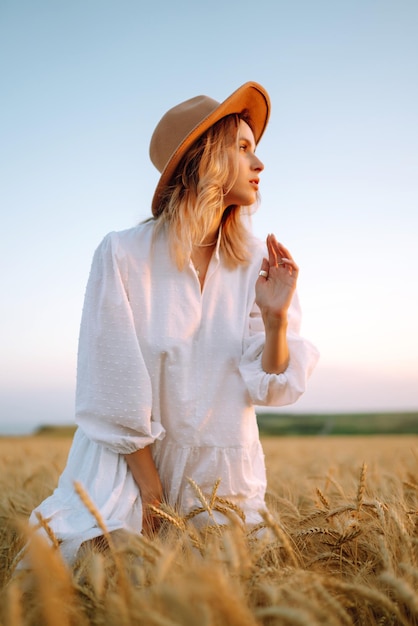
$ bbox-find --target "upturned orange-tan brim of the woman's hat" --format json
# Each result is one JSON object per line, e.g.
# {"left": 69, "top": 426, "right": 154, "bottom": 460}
{"left": 151, "top": 82, "right": 270, "bottom": 217}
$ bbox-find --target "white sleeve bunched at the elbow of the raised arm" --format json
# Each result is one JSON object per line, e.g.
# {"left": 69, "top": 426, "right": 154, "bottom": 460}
{"left": 240, "top": 294, "right": 319, "bottom": 406}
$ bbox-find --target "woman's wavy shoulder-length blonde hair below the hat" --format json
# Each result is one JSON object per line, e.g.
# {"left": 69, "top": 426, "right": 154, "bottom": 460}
{"left": 154, "top": 114, "right": 255, "bottom": 270}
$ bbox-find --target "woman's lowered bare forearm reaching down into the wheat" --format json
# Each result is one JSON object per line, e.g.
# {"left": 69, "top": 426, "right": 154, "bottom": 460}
{"left": 125, "top": 446, "right": 163, "bottom": 535}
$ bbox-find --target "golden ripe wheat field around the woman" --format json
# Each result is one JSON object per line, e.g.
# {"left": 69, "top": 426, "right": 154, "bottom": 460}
{"left": 0, "top": 436, "right": 418, "bottom": 626}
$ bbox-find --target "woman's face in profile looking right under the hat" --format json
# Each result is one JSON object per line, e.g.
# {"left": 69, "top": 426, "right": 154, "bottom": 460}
{"left": 224, "top": 120, "right": 264, "bottom": 208}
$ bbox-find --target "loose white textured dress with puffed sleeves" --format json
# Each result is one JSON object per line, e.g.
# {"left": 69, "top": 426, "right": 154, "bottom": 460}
{"left": 27, "top": 222, "right": 318, "bottom": 562}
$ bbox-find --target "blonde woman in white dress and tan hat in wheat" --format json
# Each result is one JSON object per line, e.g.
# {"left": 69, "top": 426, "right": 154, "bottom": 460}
{"left": 27, "top": 83, "right": 317, "bottom": 562}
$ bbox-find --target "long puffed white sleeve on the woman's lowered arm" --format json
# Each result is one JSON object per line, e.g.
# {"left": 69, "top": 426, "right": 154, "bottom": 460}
{"left": 76, "top": 233, "right": 165, "bottom": 454}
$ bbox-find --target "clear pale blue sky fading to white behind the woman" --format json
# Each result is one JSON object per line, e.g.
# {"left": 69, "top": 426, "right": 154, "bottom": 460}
{"left": 0, "top": 0, "right": 418, "bottom": 432}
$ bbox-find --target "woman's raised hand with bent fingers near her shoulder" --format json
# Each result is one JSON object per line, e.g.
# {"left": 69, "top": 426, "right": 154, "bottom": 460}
{"left": 255, "top": 235, "right": 299, "bottom": 326}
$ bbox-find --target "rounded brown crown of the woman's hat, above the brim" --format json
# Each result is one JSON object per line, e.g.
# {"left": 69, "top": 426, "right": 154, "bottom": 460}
{"left": 150, "top": 96, "right": 219, "bottom": 172}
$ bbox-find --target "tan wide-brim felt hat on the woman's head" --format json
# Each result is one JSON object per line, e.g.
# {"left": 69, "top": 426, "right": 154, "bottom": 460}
{"left": 149, "top": 82, "right": 270, "bottom": 217}
